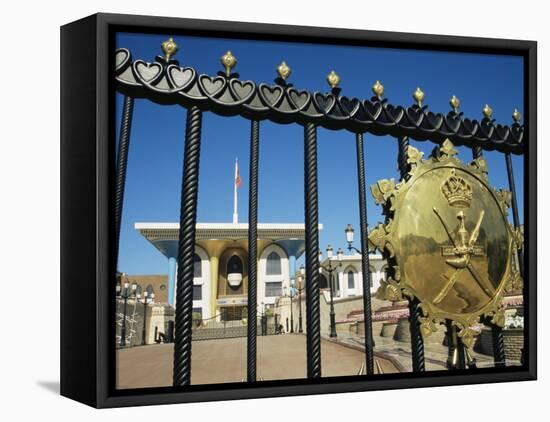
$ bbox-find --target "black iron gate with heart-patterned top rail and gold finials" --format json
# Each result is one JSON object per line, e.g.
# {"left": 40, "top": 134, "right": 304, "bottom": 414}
{"left": 115, "top": 39, "right": 524, "bottom": 386}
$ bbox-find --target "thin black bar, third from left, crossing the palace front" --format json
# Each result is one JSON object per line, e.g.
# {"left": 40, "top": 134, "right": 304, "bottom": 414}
{"left": 246, "top": 120, "right": 260, "bottom": 382}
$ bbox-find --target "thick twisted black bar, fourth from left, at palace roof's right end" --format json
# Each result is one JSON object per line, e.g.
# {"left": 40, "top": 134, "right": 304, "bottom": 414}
{"left": 304, "top": 123, "right": 321, "bottom": 378}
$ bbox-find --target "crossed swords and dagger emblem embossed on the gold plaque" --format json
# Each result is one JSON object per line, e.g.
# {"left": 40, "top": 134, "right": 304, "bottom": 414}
{"left": 433, "top": 207, "right": 495, "bottom": 304}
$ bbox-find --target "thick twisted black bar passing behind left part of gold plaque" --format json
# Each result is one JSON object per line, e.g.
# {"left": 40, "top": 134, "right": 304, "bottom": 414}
{"left": 397, "top": 136, "right": 426, "bottom": 372}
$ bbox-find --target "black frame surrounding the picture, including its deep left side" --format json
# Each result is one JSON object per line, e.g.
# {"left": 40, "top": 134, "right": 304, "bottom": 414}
{"left": 61, "top": 13, "right": 537, "bottom": 408}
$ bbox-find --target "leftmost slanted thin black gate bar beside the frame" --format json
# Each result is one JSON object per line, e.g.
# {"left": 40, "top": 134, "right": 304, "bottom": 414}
{"left": 113, "top": 96, "right": 134, "bottom": 267}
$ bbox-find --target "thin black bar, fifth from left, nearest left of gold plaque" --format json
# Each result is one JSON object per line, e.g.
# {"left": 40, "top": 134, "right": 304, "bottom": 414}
{"left": 355, "top": 133, "right": 374, "bottom": 374}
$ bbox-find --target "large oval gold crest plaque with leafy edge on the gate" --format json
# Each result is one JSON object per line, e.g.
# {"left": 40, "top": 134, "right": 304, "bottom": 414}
{"left": 369, "top": 140, "right": 520, "bottom": 346}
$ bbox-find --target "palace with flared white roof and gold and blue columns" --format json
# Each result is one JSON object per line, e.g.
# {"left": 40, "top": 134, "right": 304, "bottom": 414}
{"left": 135, "top": 223, "right": 323, "bottom": 320}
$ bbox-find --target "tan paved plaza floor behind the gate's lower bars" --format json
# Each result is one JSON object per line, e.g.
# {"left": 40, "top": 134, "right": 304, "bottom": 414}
{"left": 117, "top": 334, "right": 398, "bottom": 389}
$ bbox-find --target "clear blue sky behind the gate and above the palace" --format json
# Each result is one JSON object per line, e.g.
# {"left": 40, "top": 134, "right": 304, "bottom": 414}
{"left": 116, "top": 33, "right": 524, "bottom": 274}
